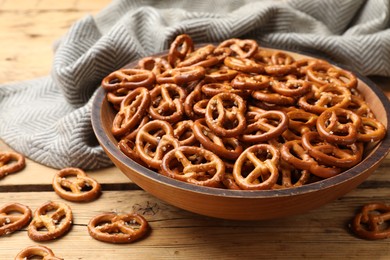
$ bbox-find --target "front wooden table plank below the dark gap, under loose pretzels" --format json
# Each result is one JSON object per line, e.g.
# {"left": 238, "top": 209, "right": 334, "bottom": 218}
{"left": 0, "top": 189, "right": 390, "bottom": 259}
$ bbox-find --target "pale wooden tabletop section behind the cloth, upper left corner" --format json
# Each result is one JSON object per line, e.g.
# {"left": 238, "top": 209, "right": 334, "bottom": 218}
{"left": 0, "top": 0, "right": 110, "bottom": 83}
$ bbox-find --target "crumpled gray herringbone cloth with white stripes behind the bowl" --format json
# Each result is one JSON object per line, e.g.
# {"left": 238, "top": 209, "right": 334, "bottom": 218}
{"left": 0, "top": 0, "right": 390, "bottom": 170}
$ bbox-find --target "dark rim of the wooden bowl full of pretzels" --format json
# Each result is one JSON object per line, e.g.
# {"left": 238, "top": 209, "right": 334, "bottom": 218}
{"left": 91, "top": 44, "right": 390, "bottom": 199}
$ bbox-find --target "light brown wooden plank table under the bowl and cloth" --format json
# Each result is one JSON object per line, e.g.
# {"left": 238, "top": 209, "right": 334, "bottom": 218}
{"left": 0, "top": 0, "right": 390, "bottom": 260}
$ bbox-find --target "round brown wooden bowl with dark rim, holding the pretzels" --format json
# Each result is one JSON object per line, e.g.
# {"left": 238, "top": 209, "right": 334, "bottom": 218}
{"left": 92, "top": 46, "right": 390, "bottom": 220}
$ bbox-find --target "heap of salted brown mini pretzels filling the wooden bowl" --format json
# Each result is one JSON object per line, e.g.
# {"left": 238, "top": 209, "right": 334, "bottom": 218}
{"left": 102, "top": 34, "right": 386, "bottom": 190}
